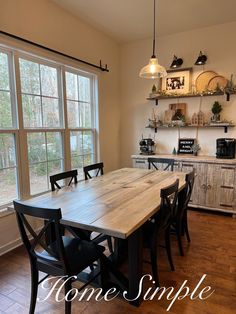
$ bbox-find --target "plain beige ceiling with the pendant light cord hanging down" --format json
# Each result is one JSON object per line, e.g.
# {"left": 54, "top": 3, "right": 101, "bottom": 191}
{"left": 51, "top": 0, "right": 236, "bottom": 43}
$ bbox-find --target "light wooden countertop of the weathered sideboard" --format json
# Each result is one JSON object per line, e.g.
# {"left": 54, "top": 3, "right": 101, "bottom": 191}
{"left": 131, "top": 154, "right": 236, "bottom": 165}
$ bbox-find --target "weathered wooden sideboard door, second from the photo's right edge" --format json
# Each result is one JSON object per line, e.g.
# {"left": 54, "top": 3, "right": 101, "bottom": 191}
{"left": 205, "top": 164, "right": 220, "bottom": 208}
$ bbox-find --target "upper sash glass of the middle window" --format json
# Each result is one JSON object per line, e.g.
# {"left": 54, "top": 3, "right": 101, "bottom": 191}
{"left": 19, "top": 58, "right": 62, "bottom": 128}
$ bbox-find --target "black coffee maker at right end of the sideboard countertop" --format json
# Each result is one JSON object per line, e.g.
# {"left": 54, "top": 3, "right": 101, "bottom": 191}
{"left": 216, "top": 138, "right": 236, "bottom": 159}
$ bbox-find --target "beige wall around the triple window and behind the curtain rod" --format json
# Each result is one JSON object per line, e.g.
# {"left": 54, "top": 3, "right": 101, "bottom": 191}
{"left": 0, "top": 0, "right": 120, "bottom": 254}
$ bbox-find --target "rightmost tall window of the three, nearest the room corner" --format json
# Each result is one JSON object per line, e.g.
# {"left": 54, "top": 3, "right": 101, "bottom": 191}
{"left": 66, "top": 71, "right": 95, "bottom": 178}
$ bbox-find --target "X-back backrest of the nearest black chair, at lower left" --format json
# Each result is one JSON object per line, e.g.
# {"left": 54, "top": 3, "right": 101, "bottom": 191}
{"left": 13, "top": 201, "right": 69, "bottom": 272}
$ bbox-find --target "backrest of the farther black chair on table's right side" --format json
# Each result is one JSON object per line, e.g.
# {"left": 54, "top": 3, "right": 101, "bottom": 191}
{"left": 177, "top": 170, "right": 195, "bottom": 217}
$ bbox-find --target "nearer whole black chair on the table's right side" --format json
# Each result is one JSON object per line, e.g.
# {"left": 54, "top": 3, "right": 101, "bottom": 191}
{"left": 143, "top": 179, "right": 179, "bottom": 287}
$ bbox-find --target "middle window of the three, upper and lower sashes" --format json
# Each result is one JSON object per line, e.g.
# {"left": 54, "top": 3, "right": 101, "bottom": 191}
{"left": 19, "top": 58, "right": 64, "bottom": 195}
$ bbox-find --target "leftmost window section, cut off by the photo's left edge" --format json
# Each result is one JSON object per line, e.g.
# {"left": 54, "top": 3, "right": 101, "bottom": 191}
{"left": 0, "top": 50, "right": 18, "bottom": 208}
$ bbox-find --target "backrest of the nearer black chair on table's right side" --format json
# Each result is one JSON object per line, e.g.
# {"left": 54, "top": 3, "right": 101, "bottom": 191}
{"left": 154, "top": 179, "right": 179, "bottom": 233}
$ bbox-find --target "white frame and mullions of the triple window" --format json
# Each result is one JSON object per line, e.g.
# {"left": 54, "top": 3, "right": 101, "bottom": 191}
{"left": 0, "top": 44, "right": 99, "bottom": 211}
